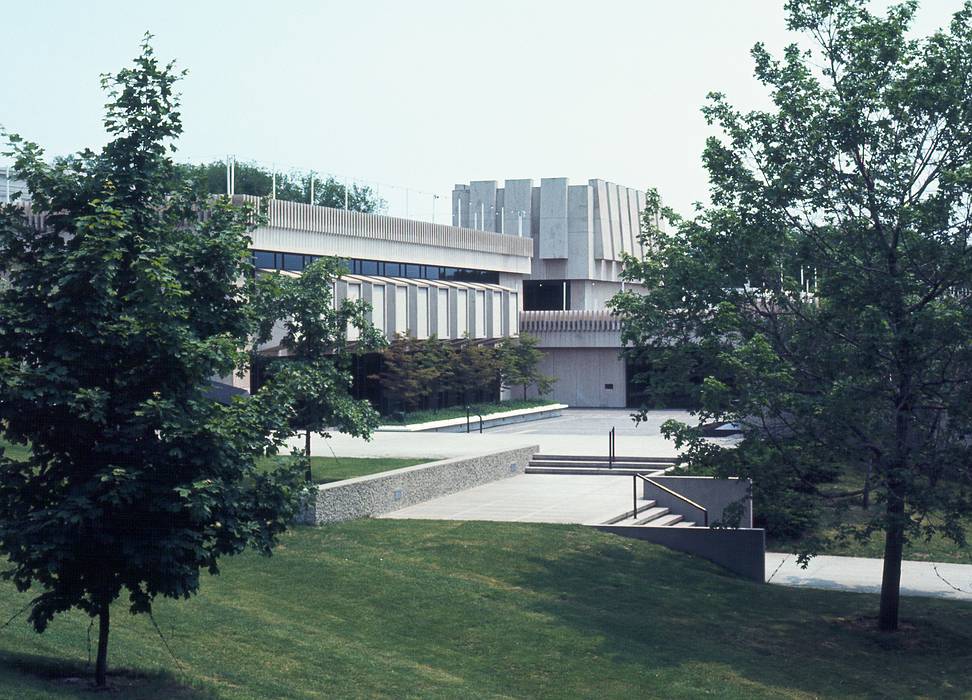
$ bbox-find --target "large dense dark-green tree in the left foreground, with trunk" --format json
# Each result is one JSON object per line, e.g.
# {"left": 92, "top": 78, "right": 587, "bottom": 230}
{"left": 0, "top": 36, "right": 378, "bottom": 686}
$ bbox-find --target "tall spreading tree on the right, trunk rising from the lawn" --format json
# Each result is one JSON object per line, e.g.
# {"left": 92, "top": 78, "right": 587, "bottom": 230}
{"left": 613, "top": 0, "right": 972, "bottom": 630}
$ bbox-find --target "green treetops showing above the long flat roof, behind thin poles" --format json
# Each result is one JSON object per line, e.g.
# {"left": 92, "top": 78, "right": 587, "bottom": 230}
{"left": 177, "top": 161, "right": 385, "bottom": 214}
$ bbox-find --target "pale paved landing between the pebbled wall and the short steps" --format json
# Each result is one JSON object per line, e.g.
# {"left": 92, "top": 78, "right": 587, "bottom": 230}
{"left": 379, "top": 474, "right": 631, "bottom": 524}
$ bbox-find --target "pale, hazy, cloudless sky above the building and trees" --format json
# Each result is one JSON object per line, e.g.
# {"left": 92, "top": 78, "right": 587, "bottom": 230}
{"left": 0, "top": 0, "right": 962, "bottom": 223}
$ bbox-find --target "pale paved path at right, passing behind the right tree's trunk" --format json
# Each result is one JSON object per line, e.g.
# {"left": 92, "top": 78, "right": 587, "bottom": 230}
{"left": 766, "top": 552, "right": 972, "bottom": 601}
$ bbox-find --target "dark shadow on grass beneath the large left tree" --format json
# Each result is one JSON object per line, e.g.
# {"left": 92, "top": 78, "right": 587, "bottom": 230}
{"left": 0, "top": 652, "right": 219, "bottom": 700}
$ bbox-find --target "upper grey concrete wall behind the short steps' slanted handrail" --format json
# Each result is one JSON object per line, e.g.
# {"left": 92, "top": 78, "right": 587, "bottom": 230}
{"left": 642, "top": 476, "right": 753, "bottom": 528}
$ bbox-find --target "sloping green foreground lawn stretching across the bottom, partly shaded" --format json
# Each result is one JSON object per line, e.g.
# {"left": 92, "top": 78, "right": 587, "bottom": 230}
{"left": 0, "top": 520, "right": 972, "bottom": 700}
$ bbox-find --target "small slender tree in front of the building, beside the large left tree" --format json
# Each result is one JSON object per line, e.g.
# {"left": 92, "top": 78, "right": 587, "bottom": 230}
{"left": 261, "top": 257, "right": 385, "bottom": 464}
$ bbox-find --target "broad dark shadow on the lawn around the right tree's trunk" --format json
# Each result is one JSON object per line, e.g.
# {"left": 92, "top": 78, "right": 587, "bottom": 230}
{"left": 504, "top": 540, "right": 972, "bottom": 697}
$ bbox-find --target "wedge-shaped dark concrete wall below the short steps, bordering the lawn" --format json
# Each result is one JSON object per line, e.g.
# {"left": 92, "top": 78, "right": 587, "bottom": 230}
{"left": 594, "top": 525, "right": 766, "bottom": 583}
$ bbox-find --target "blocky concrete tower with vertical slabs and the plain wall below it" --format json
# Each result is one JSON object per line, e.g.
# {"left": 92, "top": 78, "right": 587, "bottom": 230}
{"left": 452, "top": 178, "right": 646, "bottom": 408}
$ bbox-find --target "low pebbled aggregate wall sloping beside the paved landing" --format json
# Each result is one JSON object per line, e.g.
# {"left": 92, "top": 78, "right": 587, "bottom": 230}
{"left": 299, "top": 446, "right": 540, "bottom": 525}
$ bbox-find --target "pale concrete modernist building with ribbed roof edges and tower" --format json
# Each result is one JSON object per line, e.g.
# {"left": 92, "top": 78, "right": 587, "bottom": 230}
{"left": 0, "top": 168, "right": 645, "bottom": 407}
